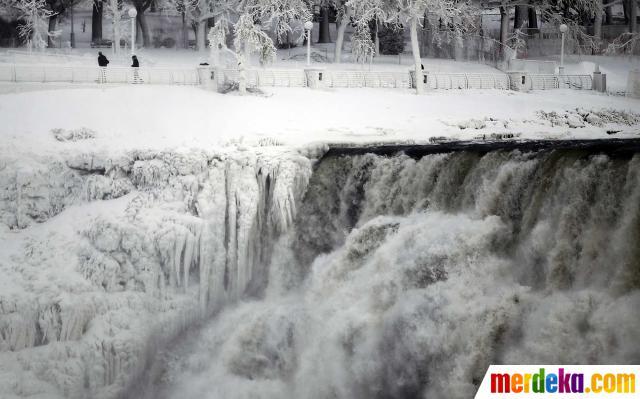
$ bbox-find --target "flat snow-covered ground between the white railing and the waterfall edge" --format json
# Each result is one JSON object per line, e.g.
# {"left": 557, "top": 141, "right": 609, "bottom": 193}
{"left": 0, "top": 84, "right": 640, "bottom": 159}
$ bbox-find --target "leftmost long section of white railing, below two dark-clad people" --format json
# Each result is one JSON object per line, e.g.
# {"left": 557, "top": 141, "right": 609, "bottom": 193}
{"left": 0, "top": 64, "right": 200, "bottom": 85}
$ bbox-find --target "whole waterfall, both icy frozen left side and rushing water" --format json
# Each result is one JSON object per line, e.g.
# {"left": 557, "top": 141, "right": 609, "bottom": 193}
{"left": 0, "top": 148, "right": 640, "bottom": 399}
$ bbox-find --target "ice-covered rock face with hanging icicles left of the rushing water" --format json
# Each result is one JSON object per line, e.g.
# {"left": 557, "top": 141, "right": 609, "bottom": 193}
{"left": 0, "top": 149, "right": 311, "bottom": 398}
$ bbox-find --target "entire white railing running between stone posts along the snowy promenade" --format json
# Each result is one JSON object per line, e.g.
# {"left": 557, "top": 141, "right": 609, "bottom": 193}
{"left": 0, "top": 64, "right": 593, "bottom": 90}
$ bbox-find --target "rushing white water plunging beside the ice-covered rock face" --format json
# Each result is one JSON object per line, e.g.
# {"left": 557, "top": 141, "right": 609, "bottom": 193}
{"left": 138, "top": 151, "right": 640, "bottom": 399}
